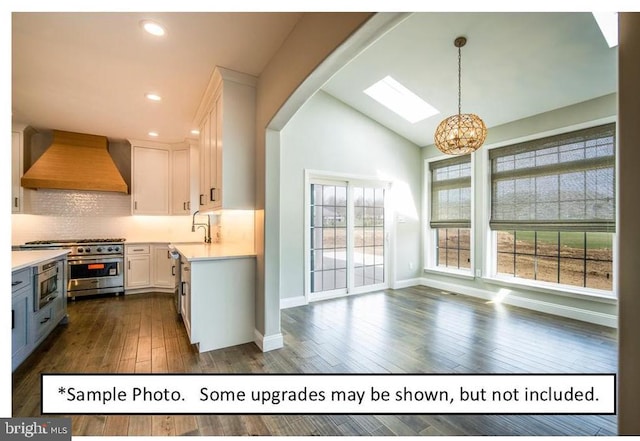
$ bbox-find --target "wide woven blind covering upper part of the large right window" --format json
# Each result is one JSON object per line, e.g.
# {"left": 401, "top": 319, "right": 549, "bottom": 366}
{"left": 489, "top": 124, "right": 615, "bottom": 232}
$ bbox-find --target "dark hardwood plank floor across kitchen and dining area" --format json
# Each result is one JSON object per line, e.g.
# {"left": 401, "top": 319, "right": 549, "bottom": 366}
{"left": 13, "top": 287, "right": 617, "bottom": 436}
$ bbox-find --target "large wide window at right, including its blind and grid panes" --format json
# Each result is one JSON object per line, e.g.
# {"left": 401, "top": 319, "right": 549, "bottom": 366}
{"left": 489, "top": 124, "right": 615, "bottom": 291}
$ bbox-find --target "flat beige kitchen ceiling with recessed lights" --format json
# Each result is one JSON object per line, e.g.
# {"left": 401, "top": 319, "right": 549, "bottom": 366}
{"left": 12, "top": 12, "right": 301, "bottom": 143}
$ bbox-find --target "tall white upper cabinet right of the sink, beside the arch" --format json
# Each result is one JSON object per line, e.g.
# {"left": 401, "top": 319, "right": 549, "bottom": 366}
{"left": 194, "top": 67, "right": 256, "bottom": 211}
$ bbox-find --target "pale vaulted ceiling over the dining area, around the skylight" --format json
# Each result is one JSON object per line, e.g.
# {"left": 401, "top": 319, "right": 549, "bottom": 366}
{"left": 323, "top": 12, "right": 618, "bottom": 146}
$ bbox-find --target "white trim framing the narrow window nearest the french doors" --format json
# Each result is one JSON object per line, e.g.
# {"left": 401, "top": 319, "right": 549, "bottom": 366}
{"left": 422, "top": 153, "right": 476, "bottom": 279}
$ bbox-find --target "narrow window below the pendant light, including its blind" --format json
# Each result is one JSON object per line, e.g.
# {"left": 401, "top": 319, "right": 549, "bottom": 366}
{"left": 429, "top": 155, "right": 471, "bottom": 270}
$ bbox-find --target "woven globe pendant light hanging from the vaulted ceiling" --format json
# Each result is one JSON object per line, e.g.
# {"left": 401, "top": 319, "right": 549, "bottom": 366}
{"left": 434, "top": 37, "right": 487, "bottom": 155}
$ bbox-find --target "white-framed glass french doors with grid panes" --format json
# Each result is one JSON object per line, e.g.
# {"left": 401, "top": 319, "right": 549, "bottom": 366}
{"left": 305, "top": 179, "right": 388, "bottom": 301}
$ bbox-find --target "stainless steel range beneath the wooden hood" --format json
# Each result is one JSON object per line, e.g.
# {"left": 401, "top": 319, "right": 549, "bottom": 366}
{"left": 21, "top": 238, "right": 125, "bottom": 298}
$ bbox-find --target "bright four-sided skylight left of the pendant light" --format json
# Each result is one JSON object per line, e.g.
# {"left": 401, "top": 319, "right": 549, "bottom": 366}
{"left": 364, "top": 76, "right": 440, "bottom": 124}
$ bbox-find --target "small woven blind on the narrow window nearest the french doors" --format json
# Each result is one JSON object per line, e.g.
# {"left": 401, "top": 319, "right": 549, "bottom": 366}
{"left": 429, "top": 155, "right": 471, "bottom": 228}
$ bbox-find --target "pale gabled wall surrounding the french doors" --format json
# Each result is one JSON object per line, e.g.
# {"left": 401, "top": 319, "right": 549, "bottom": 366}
{"left": 280, "top": 91, "right": 422, "bottom": 299}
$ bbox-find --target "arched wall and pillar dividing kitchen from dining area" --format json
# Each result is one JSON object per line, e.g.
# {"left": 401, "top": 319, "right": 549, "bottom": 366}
{"left": 255, "top": 12, "right": 373, "bottom": 340}
